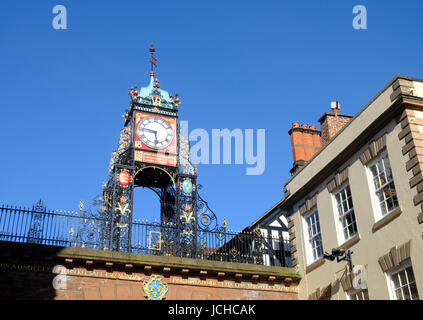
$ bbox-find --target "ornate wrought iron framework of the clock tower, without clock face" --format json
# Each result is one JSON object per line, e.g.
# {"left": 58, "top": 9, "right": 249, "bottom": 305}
{"left": 98, "top": 45, "right": 230, "bottom": 254}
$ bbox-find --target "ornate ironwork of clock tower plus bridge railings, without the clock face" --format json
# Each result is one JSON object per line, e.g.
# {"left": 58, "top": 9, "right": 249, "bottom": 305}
{"left": 0, "top": 46, "right": 292, "bottom": 265}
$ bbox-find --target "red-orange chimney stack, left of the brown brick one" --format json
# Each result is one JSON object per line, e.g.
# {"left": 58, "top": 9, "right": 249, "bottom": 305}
{"left": 288, "top": 122, "right": 322, "bottom": 174}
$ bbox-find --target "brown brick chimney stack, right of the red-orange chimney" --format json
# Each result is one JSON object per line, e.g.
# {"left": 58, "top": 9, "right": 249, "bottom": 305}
{"left": 319, "top": 101, "right": 352, "bottom": 145}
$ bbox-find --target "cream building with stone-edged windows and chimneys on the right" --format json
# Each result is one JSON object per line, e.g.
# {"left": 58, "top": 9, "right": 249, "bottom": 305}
{"left": 255, "top": 76, "right": 423, "bottom": 300}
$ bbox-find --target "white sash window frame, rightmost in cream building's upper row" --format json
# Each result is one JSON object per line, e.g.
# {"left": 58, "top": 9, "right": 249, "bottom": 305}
{"left": 366, "top": 149, "right": 399, "bottom": 221}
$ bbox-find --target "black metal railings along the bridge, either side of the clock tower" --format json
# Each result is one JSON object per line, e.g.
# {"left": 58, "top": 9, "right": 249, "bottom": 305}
{"left": 0, "top": 201, "right": 289, "bottom": 266}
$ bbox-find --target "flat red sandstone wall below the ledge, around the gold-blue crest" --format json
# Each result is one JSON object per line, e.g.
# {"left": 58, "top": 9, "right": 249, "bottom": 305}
{"left": 0, "top": 269, "right": 297, "bottom": 300}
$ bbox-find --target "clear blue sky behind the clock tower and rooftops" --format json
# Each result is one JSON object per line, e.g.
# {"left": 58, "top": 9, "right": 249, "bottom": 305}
{"left": 0, "top": 0, "right": 423, "bottom": 230}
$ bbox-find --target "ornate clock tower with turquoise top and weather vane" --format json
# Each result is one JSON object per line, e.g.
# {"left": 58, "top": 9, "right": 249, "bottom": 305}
{"left": 101, "top": 45, "right": 200, "bottom": 254}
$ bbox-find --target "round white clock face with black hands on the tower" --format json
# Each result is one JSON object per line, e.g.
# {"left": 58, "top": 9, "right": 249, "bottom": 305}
{"left": 137, "top": 116, "right": 174, "bottom": 150}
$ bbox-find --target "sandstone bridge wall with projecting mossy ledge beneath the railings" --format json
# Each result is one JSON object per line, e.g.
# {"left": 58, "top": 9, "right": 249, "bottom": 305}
{"left": 0, "top": 242, "right": 300, "bottom": 300}
